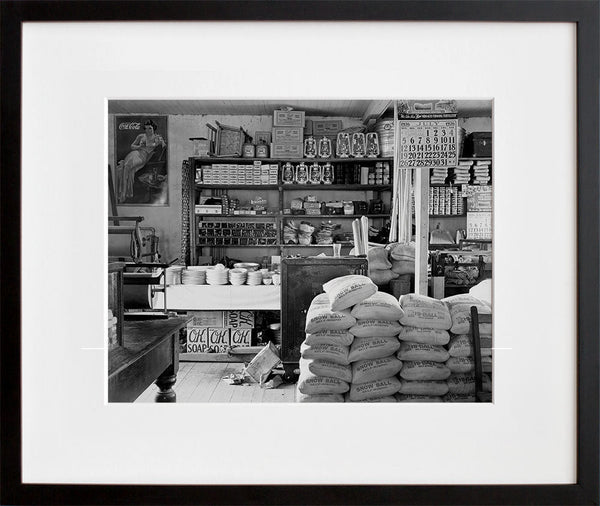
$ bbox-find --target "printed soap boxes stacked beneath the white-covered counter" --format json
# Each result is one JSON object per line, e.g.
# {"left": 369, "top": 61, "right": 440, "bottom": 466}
{"left": 185, "top": 311, "right": 254, "bottom": 353}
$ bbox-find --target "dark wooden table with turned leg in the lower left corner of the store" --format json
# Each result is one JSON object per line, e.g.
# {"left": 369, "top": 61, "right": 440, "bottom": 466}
{"left": 108, "top": 316, "right": 191, "bottom": 402}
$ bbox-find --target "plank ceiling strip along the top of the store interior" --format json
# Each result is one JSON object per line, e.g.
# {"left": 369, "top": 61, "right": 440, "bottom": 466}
{"left": 108, "top": 99, "right": 492, "bottom": 121}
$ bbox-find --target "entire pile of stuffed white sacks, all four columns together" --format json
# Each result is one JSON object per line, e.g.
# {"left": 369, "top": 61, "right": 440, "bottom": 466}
{"left": 296, "top": 275, "right": 491, "bottom": 402}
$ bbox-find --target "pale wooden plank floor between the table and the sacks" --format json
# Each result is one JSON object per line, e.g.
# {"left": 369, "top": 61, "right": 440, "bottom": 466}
{"left": 135, "top": 362, "right": 295, "bottom": 402}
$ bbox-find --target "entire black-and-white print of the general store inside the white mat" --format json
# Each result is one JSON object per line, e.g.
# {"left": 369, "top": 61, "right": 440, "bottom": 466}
{"left": 106, "top": 97, "right": 494, "bottom": 403}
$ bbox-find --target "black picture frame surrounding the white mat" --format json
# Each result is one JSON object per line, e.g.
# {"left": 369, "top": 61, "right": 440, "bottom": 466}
{"left": 0, "top": 0, "right": 600, "bottom": 505}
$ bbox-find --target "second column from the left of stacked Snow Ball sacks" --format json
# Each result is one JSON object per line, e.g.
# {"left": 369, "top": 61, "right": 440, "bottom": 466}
{"left": 346, "top": 292, "right": 404, "bottom": 402}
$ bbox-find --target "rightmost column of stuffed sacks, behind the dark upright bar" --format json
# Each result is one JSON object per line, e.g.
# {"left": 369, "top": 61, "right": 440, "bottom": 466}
{"left": 442, "top": 294, "right": 492, "bottom": 402}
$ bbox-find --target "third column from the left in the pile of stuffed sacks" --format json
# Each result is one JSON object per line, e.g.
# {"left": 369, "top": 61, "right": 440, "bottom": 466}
{"left": 396, "top": 293, "right": 452, "bottom": 402}
